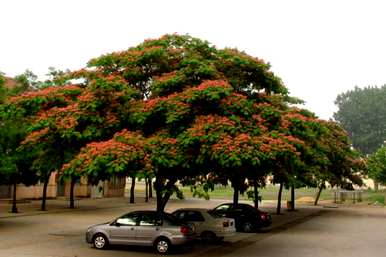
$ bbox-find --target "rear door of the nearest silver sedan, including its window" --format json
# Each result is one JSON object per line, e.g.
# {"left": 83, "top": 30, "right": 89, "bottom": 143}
{"left": 136, "top": 213, "right": 162, "bottom": 245}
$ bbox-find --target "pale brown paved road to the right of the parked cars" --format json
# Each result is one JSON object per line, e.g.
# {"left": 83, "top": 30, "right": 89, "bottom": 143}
{"left": 213, "top": 207, "right": 386, "bottom": 257}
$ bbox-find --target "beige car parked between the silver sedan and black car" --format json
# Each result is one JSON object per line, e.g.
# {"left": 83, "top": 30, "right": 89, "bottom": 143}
{"left": 172, "top": 208, "right": 236, "bottom": 241}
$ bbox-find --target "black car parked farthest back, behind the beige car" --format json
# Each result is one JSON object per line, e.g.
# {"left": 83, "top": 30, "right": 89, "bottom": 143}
{"left": 211, "top": 203, "right": 272, "bottom": 233}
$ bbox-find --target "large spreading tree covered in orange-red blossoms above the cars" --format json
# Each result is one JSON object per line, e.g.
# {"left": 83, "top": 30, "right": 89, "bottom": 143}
{"left": 4, "top": 35, "right": 364, "bottom": 211}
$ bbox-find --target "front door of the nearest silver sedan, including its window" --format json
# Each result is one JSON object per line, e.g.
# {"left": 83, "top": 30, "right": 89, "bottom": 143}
{"left": 109, "top": 213, "right": 139, "bottom": 244}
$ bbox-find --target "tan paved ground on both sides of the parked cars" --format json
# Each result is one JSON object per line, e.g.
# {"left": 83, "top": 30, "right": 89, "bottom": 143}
{"left": 0, "top": 202, "right": 386, "bottom": 257}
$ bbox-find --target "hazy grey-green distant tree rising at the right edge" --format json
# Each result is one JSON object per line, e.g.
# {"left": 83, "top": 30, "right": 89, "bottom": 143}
{"left": 334, "top": 85, "right": 386, "bottom": 154}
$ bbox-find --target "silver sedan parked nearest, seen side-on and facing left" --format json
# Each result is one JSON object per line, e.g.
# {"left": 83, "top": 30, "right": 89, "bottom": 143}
{"left": 86, "top": 211, "right": 196, "bottom": 254}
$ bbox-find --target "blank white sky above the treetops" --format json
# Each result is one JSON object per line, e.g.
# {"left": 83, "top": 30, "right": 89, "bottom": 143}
{"left": 0, "top": 0, "right": 386, "bottom": 119}
